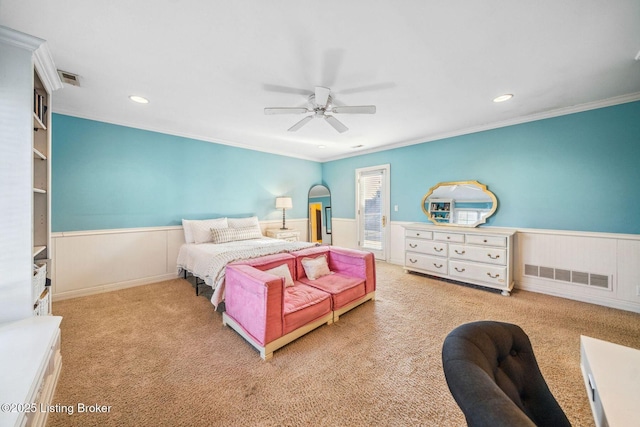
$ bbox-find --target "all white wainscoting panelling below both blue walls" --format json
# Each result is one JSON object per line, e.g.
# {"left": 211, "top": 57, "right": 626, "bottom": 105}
{"left": 51, "top": 218, "right": 640, "bottom": 313}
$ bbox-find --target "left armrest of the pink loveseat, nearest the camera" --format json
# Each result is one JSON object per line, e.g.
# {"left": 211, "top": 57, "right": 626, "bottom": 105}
{"left": 225, "top": 264, "right": 284, "bottom": 345}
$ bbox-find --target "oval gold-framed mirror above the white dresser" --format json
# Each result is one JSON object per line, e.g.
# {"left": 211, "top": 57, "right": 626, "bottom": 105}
{"left": 422, "top": 181, "right": 498, "bottom": 227}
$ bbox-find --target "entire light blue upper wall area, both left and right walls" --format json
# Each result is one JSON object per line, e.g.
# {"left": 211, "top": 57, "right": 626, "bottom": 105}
{"left": 52, "top": 102, "right": 640, "bottom": 234}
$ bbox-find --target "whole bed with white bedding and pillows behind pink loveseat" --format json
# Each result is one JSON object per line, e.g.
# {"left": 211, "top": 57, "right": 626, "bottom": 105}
{"left": 177, "top": 217, "right": 317, "bottom": 309}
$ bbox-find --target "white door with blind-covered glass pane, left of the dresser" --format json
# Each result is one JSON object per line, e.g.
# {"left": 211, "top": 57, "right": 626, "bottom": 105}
{"left": 356, "top": 165, "right": 390, "bottom": 261}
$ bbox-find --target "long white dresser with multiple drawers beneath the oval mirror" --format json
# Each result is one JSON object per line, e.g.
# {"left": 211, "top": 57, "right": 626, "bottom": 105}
{"left": 404, "top": 223, "right": 515, "bottom": 295}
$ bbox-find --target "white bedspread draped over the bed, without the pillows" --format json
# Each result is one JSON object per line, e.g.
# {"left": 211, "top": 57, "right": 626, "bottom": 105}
{"left": 177, "top": 237, "right": 316, "bottom": 307}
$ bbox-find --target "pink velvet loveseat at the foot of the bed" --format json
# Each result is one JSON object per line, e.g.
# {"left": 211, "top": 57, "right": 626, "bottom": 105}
{"left": 222, "top": 246, "right": 376, "bottom": 360}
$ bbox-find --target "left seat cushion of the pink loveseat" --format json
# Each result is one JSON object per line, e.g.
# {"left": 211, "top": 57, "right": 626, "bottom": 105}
{"left": 283, "top": 282, "right": 331, "bottom": 335}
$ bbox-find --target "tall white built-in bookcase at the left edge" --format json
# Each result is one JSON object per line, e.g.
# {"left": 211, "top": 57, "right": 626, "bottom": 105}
{"left": 0, "top": 26, "right": 62, "bottom": 322}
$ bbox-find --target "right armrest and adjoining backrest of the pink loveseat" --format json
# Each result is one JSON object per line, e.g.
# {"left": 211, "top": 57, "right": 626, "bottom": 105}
{"left": 294, "top": 246, "right": 376, "bottom": 294}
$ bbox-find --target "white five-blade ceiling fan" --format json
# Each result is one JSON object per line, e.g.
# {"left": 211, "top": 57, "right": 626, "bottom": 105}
{"left": 264, "top": 86, "right": 376, "bottom": 133}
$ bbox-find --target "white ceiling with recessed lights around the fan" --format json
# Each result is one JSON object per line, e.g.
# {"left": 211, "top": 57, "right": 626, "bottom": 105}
{"left": 0, "top": 0, "right": 640, "bottom": 161}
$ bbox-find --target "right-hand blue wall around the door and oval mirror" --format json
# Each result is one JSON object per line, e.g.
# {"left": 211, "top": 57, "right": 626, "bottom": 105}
{"left": 322, "top": 102, "right": 640, "bottom": 234}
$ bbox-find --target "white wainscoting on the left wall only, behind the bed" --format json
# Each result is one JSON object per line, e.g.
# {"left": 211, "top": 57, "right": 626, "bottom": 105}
{"left": 50, "top": 219, "right": 307, "bottom": 301}
